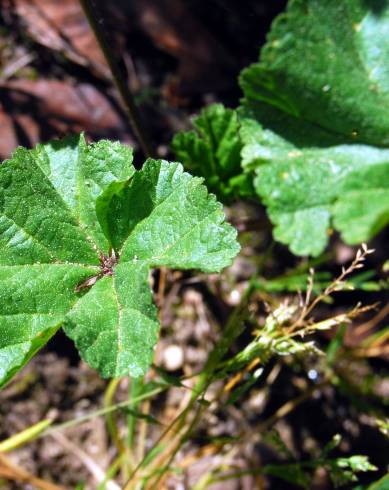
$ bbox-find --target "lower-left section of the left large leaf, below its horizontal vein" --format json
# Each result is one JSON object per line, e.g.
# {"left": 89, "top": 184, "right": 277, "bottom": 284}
{"left": 0, "top": 262, "right": 98, "bottom": 386}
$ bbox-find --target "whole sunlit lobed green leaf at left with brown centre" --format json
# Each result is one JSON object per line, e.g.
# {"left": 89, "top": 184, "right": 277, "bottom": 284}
{"left": 0, "top": 137, "right": 239, "bottom": 386}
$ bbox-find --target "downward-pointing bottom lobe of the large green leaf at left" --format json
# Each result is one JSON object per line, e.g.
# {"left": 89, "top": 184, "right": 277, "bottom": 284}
{"left": 64, "top": 262, "right": 159, "bottom": 377}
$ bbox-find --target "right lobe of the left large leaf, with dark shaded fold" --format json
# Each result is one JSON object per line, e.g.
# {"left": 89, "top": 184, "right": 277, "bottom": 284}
{"left": 98, "top": 159, "right": 239, "bottom": 272}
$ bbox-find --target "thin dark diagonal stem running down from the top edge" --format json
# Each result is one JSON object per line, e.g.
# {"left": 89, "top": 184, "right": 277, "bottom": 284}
{"left": 80, "top": 0, "right": 154, "bottom": 157}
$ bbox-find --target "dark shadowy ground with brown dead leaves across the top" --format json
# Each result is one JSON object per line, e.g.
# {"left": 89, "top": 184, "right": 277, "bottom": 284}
{"left": 0, "top": 0, "right": 286, "bottom": 158}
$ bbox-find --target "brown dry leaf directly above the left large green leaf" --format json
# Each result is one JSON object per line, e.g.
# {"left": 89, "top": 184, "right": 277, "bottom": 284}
{"left": 0, "top": 79, "right": 131, "bottom": 158}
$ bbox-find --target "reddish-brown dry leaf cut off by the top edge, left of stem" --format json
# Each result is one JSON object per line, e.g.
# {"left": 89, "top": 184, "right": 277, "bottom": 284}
{"left": 13, "top": 0, "right": 110, "bottom": 78}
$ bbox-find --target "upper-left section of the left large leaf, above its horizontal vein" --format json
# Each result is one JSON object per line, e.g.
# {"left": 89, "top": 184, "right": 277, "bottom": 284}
{"left": 0, "top": 148, "right": 98, "bottom": 266}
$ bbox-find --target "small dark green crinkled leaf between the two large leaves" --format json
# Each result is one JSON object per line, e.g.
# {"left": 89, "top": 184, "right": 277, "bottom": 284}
{"left": 171, "top": 104, "right": 253, "bottom": 201}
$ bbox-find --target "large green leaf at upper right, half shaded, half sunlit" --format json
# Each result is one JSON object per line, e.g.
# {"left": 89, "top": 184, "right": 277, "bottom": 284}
{"left": 240, "top": 0, "right": 389, "bottom": 255}
